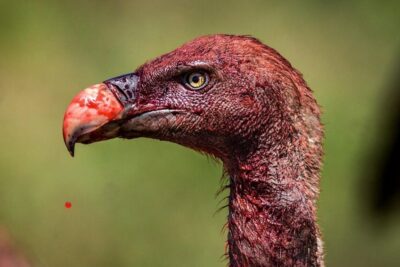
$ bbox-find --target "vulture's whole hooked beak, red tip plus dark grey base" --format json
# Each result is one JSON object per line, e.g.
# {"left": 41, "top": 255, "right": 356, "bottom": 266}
{"left": 63, "top": 74, "right": 138, "bottom": 156}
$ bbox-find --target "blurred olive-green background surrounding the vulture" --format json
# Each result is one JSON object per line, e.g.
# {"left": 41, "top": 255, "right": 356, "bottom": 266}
{"left": 0, "top": 0, "right": 400, "bottom": 267}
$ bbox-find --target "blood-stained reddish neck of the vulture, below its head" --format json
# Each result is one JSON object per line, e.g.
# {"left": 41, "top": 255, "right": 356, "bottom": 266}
{"left": 225, "top": 132, "right": 323, "bottom": 267}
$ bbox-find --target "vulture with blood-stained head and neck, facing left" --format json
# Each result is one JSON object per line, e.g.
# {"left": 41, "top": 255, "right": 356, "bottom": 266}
{"left": 63, "top": 34, "right": 324, "bottom": 267}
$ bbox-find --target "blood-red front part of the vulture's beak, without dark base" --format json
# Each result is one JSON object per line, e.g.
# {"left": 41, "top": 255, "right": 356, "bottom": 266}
{"left": 63, "top": 83, "right": 124, "bottom": 156}
